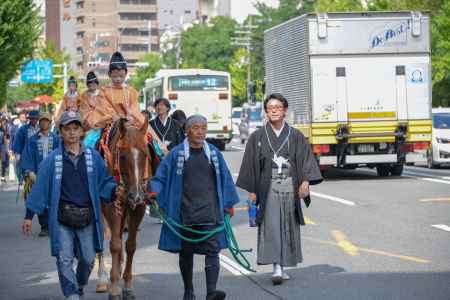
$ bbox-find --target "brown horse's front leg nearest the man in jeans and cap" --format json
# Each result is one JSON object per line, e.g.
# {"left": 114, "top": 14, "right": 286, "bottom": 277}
{"left": 107, "top": 206, "right": 126, "bottom": 300}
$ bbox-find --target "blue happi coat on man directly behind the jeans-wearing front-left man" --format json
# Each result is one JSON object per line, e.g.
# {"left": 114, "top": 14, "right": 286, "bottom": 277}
{"left": 20, "top": 132, "right": 60, "bottom": 173}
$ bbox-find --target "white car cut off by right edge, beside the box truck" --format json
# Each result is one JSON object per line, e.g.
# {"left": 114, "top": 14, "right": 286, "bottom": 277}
{"left": 427, "top": 108, "right": 450, "bottom": 168}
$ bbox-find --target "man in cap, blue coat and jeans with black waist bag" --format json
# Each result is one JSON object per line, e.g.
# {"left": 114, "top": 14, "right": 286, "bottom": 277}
{"left": 22, "top": 111, "right": 123, "bottom": 300}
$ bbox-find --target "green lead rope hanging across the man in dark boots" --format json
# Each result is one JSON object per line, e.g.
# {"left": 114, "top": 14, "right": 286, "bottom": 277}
{"left": 150, "top": 204, "right": 256, "bottom": 272}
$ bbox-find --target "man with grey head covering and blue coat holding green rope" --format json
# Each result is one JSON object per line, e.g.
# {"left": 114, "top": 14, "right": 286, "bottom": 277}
{"left": 149, "top": 115, "right": 239, "bottom": 300}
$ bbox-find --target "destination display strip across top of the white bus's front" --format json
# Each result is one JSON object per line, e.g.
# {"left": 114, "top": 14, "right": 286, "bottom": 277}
{"left": 169, "top": 75, "right": 228, "bottom": 91}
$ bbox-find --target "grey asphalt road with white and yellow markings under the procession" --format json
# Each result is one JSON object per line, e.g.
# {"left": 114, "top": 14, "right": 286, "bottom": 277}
{"left": 0, "top": 144, "right": 450, "bottom": 300}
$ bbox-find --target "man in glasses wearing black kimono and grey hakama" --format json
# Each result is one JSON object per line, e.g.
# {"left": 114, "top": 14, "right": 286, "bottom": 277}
{"left": 236, "top": 94, "right": 322, "bottom": 284}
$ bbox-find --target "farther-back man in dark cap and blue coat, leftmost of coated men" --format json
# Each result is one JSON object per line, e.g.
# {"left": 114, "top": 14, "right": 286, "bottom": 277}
{"left": 13, "top": 110, "right": 39, "bottom": 181}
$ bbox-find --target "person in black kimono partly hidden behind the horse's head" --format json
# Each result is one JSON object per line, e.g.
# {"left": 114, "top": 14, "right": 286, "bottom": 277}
{"left": 150, "top": 98, "right": 184, "bottom": 150}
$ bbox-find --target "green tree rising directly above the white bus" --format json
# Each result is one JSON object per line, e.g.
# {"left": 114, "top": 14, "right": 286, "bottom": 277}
{"left": 181, "top": 17, "right": 237, "bottom": 71}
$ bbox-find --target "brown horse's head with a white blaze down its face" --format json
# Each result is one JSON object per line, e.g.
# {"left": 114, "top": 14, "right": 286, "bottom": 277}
{"left": 113, "top": 117, "right": 152, "bottom": 209}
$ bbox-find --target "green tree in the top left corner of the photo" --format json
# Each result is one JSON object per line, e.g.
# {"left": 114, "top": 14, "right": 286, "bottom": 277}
{"left": 0, "top": 0, "right": 42, "bottom": 106}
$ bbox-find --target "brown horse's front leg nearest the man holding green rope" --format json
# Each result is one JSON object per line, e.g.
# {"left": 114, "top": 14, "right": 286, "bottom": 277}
{"left": 123, "top": 205, "right": 146, "bottom": 300}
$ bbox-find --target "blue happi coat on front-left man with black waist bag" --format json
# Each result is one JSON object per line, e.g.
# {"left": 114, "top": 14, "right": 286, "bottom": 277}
{"left": 26, "top": 143, "right": 116, "bottom": 256}
